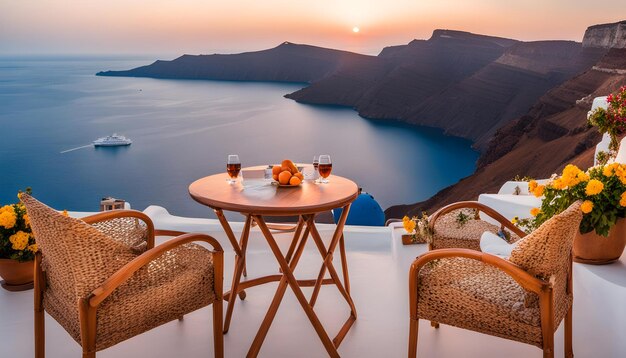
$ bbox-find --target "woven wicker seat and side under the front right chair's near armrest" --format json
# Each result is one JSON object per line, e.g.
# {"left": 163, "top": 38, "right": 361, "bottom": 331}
{"left": 417, "top": 258, "right": 542, "bottom": 347}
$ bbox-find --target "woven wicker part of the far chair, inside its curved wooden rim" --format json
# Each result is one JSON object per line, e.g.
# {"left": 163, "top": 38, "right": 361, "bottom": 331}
{"left": 432, "top": 209, "right": 519, "bottom": 251}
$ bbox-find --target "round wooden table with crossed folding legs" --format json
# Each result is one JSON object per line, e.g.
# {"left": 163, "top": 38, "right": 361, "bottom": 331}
{"left": 189, "top": 172, "right": 358, "bottom": 357}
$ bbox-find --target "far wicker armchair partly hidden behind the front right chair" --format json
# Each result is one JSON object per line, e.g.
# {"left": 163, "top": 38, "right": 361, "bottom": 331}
{"left": 428, "top": 201, "right": 526, "bottom": 251}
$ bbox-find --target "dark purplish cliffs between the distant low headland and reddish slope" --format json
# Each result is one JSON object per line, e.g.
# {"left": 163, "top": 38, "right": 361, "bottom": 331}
{"left": 286, "top": 30, "right": 606, "bottom": 151}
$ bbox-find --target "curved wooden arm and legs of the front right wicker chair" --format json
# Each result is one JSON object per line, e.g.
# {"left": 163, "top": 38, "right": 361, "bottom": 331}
{"left": 408, "top": 249, "right": 574, "bottom": 358}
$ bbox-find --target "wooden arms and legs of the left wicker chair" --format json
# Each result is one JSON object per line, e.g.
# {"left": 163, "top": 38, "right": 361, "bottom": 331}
{"left": 34, "top": 210, "right": 224, "bottom": 358}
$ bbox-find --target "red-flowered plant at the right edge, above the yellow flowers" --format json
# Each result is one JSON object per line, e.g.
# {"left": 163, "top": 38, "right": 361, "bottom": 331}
{"left": 589, "top": 86, "right": 626, "bottom": 154}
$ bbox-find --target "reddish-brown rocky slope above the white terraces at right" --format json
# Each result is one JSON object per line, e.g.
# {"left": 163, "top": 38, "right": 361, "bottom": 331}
{"left": 385, "top": 49, "right": 626, "bottom": 218}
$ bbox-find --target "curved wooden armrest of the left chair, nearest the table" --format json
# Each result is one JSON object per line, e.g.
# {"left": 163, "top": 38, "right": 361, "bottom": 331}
{"left": 87, "top": 233, "right": 224, "bottom": 307}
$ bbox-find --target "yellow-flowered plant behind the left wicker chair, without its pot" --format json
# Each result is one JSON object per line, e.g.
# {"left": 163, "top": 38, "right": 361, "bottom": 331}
{"left": 0, "top": 188, "right": 37, "bottom": 262}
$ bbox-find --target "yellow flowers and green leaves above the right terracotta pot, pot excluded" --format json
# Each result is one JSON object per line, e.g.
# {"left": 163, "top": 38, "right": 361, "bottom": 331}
{"left": 514, "top": 163, "right": 626, "bottom": 236}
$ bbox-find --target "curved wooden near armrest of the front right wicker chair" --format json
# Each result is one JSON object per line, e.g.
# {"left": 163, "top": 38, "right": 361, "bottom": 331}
{"left": 409, "top": 249, "right": 552, "bottom": 296}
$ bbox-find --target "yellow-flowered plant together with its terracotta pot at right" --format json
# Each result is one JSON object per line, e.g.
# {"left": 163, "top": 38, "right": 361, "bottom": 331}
{"left": 517, "top": 163, "right": 626, "bottom": 264}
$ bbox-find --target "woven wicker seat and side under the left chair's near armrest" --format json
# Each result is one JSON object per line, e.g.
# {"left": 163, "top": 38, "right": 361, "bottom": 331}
{"left": 96, "top": 244, "right": 215, "bottom": 350}
